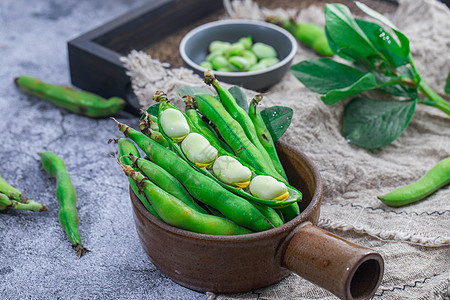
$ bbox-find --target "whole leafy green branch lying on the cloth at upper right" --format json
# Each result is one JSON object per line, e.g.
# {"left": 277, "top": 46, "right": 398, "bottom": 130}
{"left": 291, "top": 2, "right": 450, "bottom": 149}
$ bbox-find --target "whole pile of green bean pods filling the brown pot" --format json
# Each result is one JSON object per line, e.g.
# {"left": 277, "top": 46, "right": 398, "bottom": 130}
{"left": 116, "top": 71, "right": 302, "bottom": 235}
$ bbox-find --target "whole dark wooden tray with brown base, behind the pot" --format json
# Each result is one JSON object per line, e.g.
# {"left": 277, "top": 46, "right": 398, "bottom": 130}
{"left": 68, "top": 0, "right": 396, "bottom": 113}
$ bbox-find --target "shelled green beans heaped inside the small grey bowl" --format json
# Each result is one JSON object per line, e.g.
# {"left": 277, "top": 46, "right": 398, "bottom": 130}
{"left": 200, "top": 36, "right": 280, "bottom": 72}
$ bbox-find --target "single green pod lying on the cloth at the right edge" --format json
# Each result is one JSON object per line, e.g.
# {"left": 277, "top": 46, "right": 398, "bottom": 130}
{"left": 378, "top": 157, "right": 450, "bottom": 206}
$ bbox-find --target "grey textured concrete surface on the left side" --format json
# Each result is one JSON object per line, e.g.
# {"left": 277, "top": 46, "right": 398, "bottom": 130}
{"left": 0, "top": 0, "right": 206, "bottom": 299}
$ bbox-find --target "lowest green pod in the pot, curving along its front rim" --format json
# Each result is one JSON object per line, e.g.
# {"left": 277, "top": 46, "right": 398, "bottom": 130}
{"left": 122, "top": 165, "right": 252, "bottom": 235}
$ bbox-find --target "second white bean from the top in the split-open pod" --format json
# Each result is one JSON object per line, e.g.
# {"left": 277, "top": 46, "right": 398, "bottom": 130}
{"left": 181, "top": 132, "right": 217, "bottom": 167}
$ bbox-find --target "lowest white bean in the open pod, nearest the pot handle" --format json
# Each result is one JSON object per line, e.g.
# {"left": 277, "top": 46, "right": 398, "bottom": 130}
{"left": 250, "top": 175, "right": 289, "bottom": 200}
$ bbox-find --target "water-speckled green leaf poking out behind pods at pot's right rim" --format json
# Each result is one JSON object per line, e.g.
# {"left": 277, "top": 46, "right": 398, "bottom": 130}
{"left": 261, "top": 106, "right": 294, "bottom": 142}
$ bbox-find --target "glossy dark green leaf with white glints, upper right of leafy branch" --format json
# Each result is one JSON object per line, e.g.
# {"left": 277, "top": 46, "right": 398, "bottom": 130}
{"left": 356, "top": 19, "right": 409, "bottom": 69}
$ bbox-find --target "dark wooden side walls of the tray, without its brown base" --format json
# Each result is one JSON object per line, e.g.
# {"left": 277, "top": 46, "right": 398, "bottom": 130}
{"left": 68, "top": 0, "right": 223, "bottom": 112}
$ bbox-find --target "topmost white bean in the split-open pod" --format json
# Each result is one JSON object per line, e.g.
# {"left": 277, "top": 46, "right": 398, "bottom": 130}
{"left": 160, "top": 108, "right": 190, "bottom": 141}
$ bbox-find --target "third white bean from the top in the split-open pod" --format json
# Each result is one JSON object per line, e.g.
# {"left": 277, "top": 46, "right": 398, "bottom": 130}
{"left": 213, "top": 155, "right": 252, "bottom": 188}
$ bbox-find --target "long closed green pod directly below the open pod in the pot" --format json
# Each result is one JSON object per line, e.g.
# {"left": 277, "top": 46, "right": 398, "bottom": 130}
{"left": 112, "top": 121, "right": 274, "bottom": 231}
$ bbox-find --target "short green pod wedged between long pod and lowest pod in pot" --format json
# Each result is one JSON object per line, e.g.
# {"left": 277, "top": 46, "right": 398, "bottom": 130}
{"left": 128, "top": 154, "right": 207, "bottom": 214}
